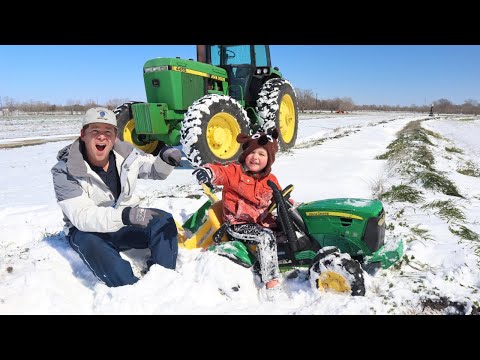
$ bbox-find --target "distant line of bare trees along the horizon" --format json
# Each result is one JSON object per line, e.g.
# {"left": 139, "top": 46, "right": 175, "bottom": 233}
{"left": 0, "top": 89, "right": 480, "bottom": 115}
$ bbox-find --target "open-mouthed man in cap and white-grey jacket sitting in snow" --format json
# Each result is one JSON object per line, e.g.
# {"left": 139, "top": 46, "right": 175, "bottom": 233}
{"left": 51, "top": 107, "right": 181, "bottom": 287}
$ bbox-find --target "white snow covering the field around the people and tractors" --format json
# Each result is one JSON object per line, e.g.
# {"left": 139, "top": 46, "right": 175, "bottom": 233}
{"left": 0, "top": 112, "right": 480, "bottom": 314}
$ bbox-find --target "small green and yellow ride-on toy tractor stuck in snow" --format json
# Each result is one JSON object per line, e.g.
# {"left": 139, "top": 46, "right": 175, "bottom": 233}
{"left": 177, "top": 181, "right": 403, "bottom": 296}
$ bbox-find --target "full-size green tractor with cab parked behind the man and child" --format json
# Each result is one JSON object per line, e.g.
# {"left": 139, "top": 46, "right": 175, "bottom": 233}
{"left": 114, "top": 45, "right": 298, "bottom": 166}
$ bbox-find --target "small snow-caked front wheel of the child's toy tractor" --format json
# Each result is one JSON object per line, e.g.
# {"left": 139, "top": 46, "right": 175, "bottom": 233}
{"left": 309, "top": 246, "right": 365, "bottom": 296}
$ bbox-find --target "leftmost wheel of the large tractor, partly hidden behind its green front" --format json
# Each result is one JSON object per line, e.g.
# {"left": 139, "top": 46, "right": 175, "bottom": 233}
{"left": 113, "top": 101, "right": 165, "bottom": 155}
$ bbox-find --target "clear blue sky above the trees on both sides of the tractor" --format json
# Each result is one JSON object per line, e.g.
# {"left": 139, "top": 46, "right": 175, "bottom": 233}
{"left": 0, "top": 45, "right": 480, "bottom": 106}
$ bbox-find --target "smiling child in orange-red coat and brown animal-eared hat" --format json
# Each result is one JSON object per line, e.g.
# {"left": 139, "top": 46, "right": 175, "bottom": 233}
{"left": 193, "top": 129, "right": 281, "bottom": 300}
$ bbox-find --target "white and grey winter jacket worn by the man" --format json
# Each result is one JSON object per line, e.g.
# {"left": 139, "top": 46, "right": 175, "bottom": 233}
{"left": 51, "top": 139, "right": 174, "bottom": 235}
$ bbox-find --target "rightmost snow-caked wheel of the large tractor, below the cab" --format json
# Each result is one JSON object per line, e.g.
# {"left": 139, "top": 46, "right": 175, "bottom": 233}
{"left": 257, "top": 78, "right": 298, "bottom": 150}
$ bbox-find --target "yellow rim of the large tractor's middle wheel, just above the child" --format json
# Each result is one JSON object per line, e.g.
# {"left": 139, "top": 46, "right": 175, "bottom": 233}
{"left": 206, "top": 112, "right": 241, "bottom": 160}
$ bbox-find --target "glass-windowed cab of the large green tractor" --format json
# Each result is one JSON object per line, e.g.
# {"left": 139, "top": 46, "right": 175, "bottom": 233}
{"left": 197, "top": 45, "right": 278, "bottom": 106}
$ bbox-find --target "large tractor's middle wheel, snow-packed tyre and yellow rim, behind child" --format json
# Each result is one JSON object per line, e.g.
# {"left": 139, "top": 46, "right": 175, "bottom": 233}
{"left": 180, "top": 94, "right": 250, "bottom": 167}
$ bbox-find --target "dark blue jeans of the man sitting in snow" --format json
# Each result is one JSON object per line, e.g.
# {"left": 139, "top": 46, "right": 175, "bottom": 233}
{"left": 67, "top": 210, "right": 178, "bottom": 287}
